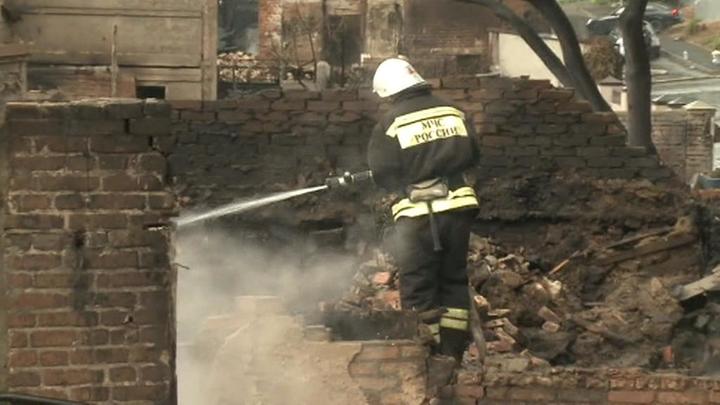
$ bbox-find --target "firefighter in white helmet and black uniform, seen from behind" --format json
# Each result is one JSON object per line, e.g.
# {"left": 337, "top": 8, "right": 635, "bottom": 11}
{"left": 368, "top": 57, "right": 478, "bottom": 361}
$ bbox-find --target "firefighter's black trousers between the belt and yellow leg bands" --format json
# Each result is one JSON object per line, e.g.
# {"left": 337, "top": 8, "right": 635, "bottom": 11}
{"left": 393, "top": 209, "right": 476, "bottom": 312}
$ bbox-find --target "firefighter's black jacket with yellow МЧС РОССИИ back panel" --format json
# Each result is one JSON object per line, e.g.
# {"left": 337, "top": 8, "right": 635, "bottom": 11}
{"left": 368, "top": 86, "right": 478, "bottom": 194}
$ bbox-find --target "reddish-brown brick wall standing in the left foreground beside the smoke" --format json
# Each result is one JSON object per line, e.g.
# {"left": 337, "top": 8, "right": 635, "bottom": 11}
{"left": 1, "top": 101, "right": 175, "bottom": 403}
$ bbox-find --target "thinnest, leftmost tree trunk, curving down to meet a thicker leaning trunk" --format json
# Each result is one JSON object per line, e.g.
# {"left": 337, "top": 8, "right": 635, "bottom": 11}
{"left": 456, "top": 0, "right": 575, "bottom": 87}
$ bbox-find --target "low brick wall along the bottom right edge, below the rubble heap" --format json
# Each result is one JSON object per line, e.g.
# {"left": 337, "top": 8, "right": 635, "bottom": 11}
{"left": 452, "top": 368, "right": 720, "bottom": 405}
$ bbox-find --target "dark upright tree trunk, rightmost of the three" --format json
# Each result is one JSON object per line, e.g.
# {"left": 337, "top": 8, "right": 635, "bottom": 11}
{"left": 620, "top": 0, "right": 655, "bottom": 153}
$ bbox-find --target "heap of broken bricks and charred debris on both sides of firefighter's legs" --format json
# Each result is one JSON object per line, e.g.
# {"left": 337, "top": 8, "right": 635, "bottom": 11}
{"left": 326, "top": 218, "right": 720, "bottom": 374}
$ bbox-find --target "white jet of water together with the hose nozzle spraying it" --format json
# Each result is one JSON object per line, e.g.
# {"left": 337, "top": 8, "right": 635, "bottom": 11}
{"left": 175, "top": 170, "right": 372, "bottom": 227}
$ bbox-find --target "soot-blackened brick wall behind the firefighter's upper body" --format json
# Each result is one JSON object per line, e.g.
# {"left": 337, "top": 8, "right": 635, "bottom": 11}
{"left": 170, "top": 77, "right": 671, "bottom": 210}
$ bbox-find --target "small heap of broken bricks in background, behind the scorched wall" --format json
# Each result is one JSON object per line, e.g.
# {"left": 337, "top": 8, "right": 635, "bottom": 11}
{"left": 217, "top": 51, "right": 278, "bottom": 83}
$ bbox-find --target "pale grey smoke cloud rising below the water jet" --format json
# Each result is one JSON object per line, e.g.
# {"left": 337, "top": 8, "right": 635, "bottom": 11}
{"left": 176, "top": 223, "right": 366, "bottom": 404}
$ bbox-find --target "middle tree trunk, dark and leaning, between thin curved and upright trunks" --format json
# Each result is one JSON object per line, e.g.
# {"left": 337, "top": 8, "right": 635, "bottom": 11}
{"left": 530, "top": 0, "right": 612, "bottom": 111}
